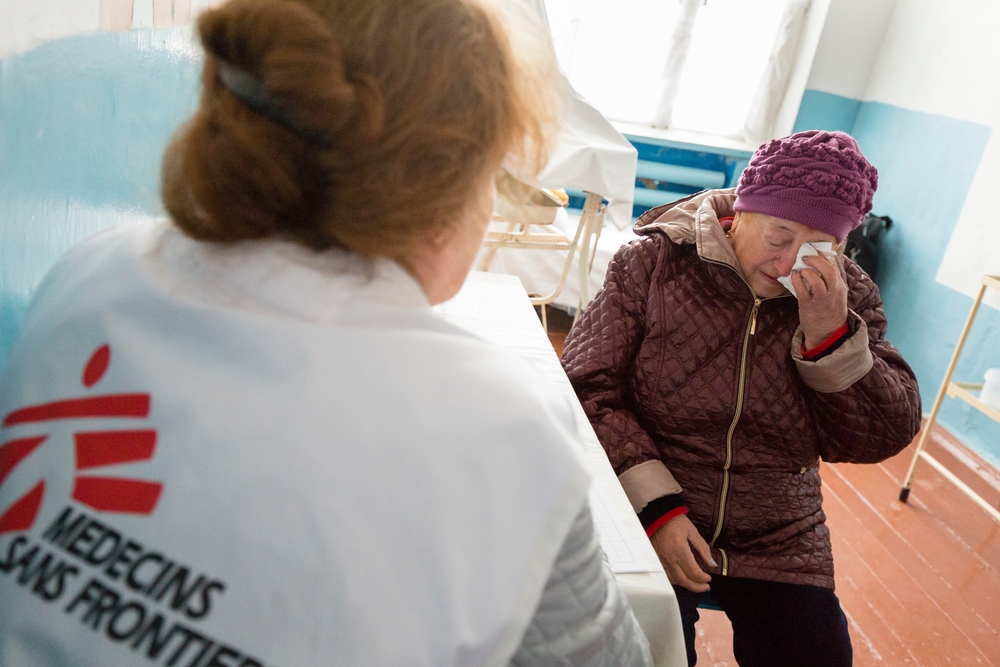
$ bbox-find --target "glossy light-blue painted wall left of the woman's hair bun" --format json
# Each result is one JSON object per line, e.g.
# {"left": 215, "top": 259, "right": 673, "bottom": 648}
{"left": 0, "top": 28, "right": 201, "bottom": 366}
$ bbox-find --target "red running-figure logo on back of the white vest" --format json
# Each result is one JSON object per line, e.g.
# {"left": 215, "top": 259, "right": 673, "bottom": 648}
{"left": 0, "top": 345, "right": 163, "bottom": 535}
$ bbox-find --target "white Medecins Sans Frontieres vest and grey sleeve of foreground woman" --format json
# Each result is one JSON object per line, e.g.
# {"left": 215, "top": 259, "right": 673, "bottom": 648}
{"left": 0, "top": 222, "right": 649, "bottom": 667}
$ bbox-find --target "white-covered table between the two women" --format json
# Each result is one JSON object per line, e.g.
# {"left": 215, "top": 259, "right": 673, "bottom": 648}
{"left": 436, "top": 272, "right": 687, "bottom": 667}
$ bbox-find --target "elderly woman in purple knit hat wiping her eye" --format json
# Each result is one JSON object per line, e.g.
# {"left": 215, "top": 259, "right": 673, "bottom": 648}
{"left": 563, "top": 131, "right": 920, "bottom": 666}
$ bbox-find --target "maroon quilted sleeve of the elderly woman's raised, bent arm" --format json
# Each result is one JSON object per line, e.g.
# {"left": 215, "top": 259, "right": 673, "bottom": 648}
{"left": 792, "top": 262, "right": 920, "bottom": 463}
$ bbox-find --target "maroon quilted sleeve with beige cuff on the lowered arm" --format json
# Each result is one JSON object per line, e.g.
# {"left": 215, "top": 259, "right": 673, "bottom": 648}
{"left": 562, "top": 240, "right": 681, "bottom": 512}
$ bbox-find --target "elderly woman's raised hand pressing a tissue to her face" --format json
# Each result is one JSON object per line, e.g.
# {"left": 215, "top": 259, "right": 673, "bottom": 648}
{"left": 791, "top": 255, "right": 847, "bottom": 349}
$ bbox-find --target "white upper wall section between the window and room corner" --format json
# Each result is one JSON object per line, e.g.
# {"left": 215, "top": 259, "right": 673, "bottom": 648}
{"left": 806, "top": 0, "right": 909, "bottom": 100}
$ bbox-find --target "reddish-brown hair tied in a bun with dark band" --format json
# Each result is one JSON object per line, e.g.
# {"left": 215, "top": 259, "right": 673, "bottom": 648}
{"left": 162, "top": 0, "right": 556, "bottom": 258}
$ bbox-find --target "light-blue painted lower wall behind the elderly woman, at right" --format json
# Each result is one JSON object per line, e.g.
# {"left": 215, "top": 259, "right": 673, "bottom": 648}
{"left": 795, "top": 90, "right": 1000, "bottom": 466}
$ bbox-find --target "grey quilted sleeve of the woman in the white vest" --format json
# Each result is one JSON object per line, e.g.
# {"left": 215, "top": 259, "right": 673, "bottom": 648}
{"left": 510, "top": 504, "right": 653, "bottom": 667}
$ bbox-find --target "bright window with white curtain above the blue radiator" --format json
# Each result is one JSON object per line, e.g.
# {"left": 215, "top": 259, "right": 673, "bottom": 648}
{"left": 545, "top": 0, "right": 810, "bottom": 145}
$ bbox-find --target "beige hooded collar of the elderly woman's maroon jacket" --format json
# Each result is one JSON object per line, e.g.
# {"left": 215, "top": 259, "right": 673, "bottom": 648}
{"left": 635, "top": 188, "right": 743, "bottom": 276}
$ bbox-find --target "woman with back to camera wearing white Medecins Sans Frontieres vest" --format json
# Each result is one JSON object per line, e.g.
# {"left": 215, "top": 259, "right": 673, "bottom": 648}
{"left": 0, "top": 0, "right": 651, "bottom": 667}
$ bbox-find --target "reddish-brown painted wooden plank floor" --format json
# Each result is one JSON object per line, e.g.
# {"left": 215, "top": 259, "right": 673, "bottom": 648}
{"left": 549, "top": 310, "right": 1000, "bottom": 667}
